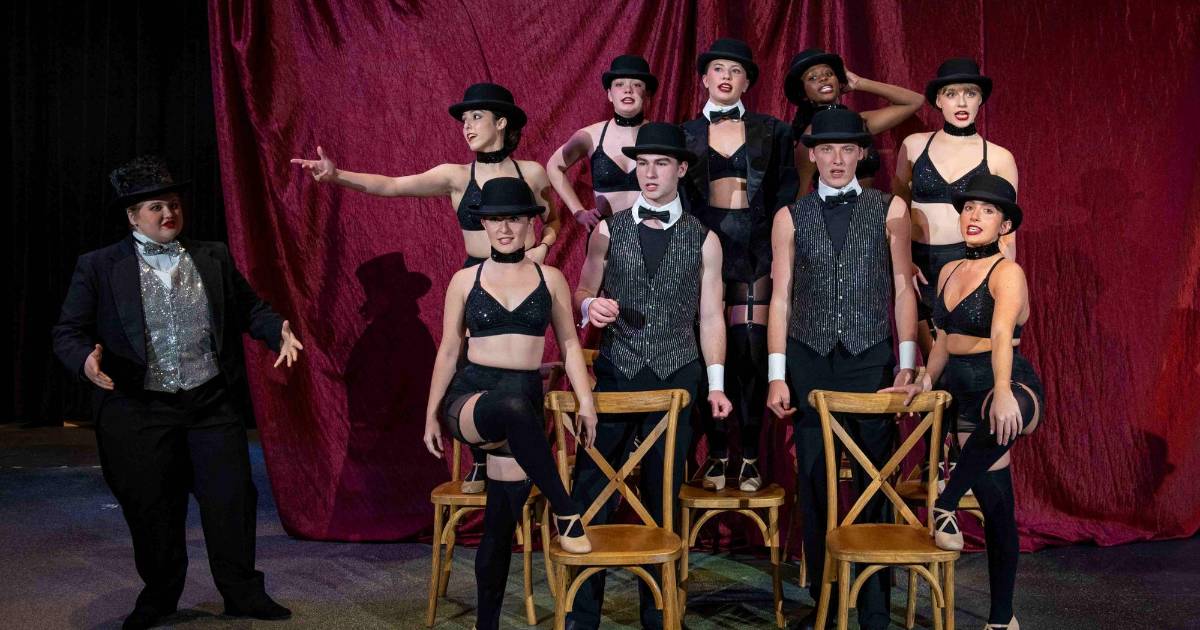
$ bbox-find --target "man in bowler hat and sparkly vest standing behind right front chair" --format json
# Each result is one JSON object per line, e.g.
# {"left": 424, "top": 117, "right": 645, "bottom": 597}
{"left": 767, "top": 109, "right": 917, "bottom": 629}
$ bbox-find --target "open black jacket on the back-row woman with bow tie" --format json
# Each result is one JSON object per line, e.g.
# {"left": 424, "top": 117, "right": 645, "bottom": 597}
{"left": 683, "top": 112, "right": 800, "bottom": 217}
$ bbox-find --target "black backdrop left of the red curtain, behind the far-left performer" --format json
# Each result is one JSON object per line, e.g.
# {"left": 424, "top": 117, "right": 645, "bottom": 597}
{"left": 10, "top": 0, "right": 226, "bottom": 424}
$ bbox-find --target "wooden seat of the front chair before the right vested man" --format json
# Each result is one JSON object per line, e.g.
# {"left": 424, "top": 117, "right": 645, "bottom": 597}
{"left": 826, "top": 523, "right": 959, "bottom": 564}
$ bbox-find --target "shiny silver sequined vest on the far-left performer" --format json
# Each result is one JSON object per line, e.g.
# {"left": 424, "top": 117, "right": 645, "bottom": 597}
{"left": 138, "top": 252, "right": 221, "bottom": 392}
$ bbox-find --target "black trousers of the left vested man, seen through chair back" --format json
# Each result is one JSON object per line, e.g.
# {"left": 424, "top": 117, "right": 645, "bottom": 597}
{"left": 568, "top": 355, "right": 707, "bottom": 630}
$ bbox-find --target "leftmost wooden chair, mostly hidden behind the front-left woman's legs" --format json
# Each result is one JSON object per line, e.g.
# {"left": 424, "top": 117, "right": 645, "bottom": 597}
{"left": 425, "top": 432, "right": 550, "bottom": 628}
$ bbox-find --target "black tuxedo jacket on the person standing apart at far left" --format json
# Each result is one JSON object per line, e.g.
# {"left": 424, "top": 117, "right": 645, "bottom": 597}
{"left": 53, "top": 235, "right": 283, "bottom": 409}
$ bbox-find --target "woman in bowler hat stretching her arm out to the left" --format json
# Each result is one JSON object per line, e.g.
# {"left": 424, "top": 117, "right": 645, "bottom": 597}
{"left": 292, "top": 83, "right": 559, "bottom": 494}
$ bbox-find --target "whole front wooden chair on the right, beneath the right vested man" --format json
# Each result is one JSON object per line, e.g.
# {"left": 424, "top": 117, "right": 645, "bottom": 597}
{"left": 809, "top": 390, "right": 959, "bottom": 630}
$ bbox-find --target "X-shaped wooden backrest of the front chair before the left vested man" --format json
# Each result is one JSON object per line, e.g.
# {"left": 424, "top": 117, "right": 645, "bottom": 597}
{"left": 546, "top": 389, "right": 689, "bottom": 529}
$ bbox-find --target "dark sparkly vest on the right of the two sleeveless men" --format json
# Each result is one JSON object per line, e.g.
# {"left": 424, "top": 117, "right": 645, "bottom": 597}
{"left": 787, "top": 188, "right": 893, "bottom": 354}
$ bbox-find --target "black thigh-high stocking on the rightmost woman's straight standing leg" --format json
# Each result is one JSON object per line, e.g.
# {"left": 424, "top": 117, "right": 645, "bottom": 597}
{"left": 972, "top": 466, "right": 1021, "bottom": 624}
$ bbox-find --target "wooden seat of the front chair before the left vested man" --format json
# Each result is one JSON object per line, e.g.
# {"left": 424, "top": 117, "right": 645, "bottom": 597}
{"left": 550, "top": 524, "right": 683, "bottom": 566}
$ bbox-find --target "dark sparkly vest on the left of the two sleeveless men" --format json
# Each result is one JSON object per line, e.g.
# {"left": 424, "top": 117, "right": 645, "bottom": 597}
{"left": 600, "top": 210, "right": 708, "bottom": 379}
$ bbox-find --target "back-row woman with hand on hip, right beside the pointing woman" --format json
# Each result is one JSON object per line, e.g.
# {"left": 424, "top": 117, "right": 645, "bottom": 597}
{"left": 546, "top": 55, "right": 659, "bottom": 229}
